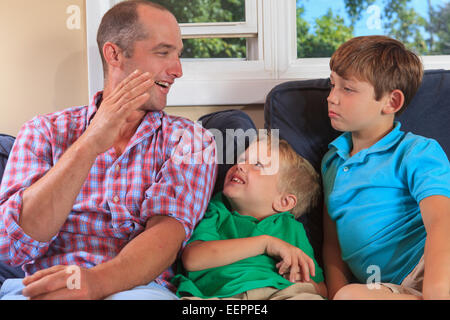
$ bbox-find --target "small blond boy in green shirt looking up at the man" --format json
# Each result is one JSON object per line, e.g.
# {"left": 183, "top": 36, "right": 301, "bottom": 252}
{"left": 173, "top": 137, "right": 327, "bottom": 300}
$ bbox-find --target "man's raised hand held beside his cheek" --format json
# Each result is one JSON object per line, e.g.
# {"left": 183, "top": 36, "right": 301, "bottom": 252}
{"left": 82, "top": 70, "right": 154, "bottom": 154}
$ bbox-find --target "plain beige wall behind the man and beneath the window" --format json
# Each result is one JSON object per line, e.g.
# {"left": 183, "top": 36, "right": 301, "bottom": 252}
{"left": 0, "top": 0, "right": 263, "bottom": 136}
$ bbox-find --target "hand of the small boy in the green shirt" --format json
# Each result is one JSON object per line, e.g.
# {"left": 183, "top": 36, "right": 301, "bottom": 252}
{"left": 266, "top": 237, "right": 315, "bottom": 282}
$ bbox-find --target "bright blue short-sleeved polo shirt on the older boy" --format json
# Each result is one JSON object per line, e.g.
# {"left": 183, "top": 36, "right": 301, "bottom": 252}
{"left": 322, "top": 122, "right": 450, "bottom": 284}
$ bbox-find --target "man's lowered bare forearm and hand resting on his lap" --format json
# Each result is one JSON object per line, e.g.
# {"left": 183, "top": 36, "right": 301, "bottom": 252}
{"left": 22, "top": 216, "right": 185, "bottom": 299}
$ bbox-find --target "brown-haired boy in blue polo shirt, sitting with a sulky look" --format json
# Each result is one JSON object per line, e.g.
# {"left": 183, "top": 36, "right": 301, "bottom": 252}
{"left": 322, "top": 36, "right": 450, "bottom": 299}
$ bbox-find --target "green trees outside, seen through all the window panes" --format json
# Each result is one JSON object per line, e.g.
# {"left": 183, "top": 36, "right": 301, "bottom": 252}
{"left": 147, "top": 0, "right": 450, "bottom": 58}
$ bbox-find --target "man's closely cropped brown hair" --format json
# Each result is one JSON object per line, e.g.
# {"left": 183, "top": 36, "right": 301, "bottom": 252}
{"left": 97, "top": 0, "right": 168, "bottom": 76}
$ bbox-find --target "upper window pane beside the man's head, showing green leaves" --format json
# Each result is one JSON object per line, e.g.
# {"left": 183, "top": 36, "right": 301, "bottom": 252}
{"left": 152, "top": 0, "right": 245, "bottom": 23}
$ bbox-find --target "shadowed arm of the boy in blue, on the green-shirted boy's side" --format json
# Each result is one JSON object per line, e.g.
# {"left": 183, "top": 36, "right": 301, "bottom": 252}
{"left": 322, "top": 205, "right": 351, "bottom": 299}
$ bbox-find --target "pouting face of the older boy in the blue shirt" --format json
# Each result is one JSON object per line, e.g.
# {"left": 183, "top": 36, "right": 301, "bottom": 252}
{"left": 327, "top": 71, "right": 389, "bottom": 133}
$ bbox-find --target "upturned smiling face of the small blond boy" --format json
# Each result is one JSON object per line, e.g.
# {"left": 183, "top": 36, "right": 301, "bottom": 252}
{"left": 223, "top": 141, "right": 282, "bottom": 220}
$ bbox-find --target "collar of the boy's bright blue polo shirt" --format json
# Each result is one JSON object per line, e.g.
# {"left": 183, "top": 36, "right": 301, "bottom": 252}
{"left": 329, "top": 121, "right": 405, "bottom": 162}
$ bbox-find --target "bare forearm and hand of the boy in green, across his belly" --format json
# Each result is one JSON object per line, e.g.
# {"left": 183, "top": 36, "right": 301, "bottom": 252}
{"left": 182, "top": 235, "right": 315, "bottom": 282}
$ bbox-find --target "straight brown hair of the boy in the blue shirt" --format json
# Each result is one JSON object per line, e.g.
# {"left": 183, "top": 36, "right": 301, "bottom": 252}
{"left": 330, "top": 36, "right": 423, "bottom": 114}
